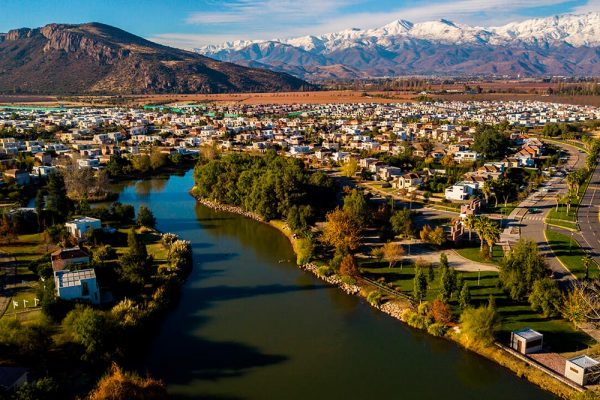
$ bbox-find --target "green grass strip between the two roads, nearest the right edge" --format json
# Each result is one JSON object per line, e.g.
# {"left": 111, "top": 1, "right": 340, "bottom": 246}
{"left": 546, "top": 230, "right": 600, "bottom": 279}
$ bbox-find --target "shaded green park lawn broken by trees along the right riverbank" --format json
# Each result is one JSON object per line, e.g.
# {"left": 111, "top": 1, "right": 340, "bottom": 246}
{"left": 361, "top": 261, "right": 595, "bottom": 353}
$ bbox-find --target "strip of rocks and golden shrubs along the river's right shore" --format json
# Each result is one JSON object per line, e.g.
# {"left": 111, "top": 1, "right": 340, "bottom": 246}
{"left": 190, "top": 192, "right": 580, "bottom": 399}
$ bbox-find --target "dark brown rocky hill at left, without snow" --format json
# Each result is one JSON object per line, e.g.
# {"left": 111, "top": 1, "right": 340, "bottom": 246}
{"left": 0, "top": 23, "right": 311, "bottom": 94}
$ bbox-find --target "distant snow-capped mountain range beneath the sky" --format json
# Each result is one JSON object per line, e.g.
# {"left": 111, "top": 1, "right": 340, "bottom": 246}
{"left": 194, "top": 13, "right": 600, "bottom": 80}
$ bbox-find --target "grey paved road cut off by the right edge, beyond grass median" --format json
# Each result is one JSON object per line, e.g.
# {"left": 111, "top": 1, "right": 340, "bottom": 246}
{"left": 577, "top": 159, "right": 600, "bottom": 265}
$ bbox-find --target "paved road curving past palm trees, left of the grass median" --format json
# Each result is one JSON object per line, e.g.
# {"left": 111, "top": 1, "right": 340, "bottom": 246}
{"left": 502, "top": 143, "right": 584, "bottom": 281}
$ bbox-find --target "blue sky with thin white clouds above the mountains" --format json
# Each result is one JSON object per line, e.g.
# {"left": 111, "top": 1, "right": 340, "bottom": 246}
{"left": 0, "top": 0, "right": 600, "bottom": 48}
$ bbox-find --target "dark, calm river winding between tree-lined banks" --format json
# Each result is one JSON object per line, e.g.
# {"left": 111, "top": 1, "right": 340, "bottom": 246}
{"left": 109, "top": 171, "right": 553, "bottom": 400}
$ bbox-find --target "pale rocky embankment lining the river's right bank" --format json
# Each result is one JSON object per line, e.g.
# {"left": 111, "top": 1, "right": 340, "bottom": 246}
{"left": 191, "top": 195, "right": 577, "bottom": 399}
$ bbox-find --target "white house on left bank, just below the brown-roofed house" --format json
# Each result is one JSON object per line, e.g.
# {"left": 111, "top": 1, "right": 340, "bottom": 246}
{"left": 54, "top": 268, "right": 100, "bottom": 304}
